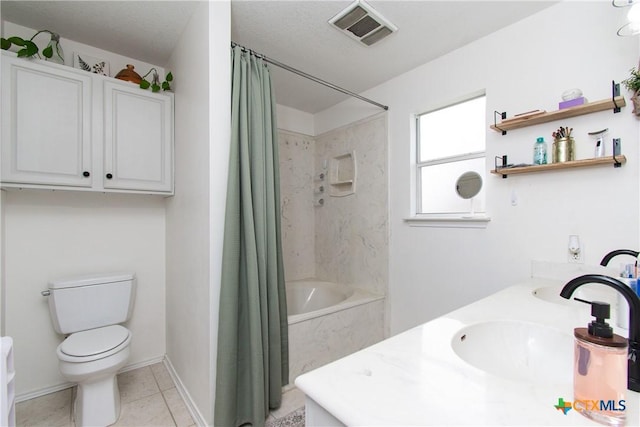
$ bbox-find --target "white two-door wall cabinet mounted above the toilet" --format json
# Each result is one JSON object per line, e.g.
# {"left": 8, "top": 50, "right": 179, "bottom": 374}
{"left": 1, "top": 52, "right": 173, "bottom": 195}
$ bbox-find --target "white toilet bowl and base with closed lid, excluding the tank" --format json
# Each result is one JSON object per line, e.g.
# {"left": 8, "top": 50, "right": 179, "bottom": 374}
{"left": 56, "top": 325, "right": 131, "bottom": 426}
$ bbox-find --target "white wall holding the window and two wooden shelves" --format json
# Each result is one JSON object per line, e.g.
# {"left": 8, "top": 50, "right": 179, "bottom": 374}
{"left": 314, "top": 2, "right": 640, "bottom": 333}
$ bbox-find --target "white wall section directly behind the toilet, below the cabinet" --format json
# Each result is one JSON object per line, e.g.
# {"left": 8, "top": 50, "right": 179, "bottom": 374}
{"left": 3, "top": 190, "right": 165, "bottom": 398}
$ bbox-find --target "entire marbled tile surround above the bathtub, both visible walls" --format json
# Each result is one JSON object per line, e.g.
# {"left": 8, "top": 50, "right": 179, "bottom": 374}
{"left": 279, "top": 113, "right": 389, "bottom": 295}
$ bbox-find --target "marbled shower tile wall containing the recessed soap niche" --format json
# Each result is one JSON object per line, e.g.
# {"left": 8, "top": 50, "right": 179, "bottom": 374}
{"left": 315, "top": 113, "right": 389, "bottom": 295}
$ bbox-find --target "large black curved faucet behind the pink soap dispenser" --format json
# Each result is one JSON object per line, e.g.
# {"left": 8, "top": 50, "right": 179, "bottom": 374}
{"left": 560, "top": 274, "right": 640, "bottom": 392}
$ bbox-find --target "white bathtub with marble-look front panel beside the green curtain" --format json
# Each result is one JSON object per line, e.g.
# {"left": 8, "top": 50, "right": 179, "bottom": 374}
{"left": 286, "top": 279, "right": 385, "bottom": 384}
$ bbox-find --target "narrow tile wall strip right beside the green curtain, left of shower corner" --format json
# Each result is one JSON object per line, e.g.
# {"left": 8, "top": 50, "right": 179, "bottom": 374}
{"left": 278, "top": 130, "right": 316, "bottom": 280}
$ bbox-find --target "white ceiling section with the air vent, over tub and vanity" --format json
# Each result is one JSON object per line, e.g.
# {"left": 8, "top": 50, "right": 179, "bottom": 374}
{"left": 231, "top": 0, "right": 553, "bottom": 113}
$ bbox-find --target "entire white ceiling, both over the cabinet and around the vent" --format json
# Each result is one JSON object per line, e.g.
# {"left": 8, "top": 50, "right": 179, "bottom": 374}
{"left": 0, "top": 0, "right": 555, "bottom": 113}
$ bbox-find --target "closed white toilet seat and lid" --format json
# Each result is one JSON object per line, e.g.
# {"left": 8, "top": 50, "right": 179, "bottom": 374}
{"left": 57, "top": 325, "right": 131, "bottom": 363}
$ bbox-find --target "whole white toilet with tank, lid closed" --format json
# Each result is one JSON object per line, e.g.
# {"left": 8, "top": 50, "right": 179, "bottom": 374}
{"left": 43, "top": 273, "right": 136, "bottom": 426}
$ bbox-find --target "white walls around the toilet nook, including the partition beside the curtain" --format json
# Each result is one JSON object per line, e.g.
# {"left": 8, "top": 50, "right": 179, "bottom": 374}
{"left": 0, "top": 1, "right": 231, "bottom": 424}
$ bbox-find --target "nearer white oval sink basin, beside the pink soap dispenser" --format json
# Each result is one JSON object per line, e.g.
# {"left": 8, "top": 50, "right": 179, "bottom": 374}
{"left": 451, "top": 320, "right": 573, "bottom": 384}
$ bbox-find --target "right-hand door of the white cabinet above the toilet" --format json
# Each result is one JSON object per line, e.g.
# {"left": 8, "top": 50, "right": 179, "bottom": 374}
{"left": 104, "top": 82, "right": 173, "bottom": 192}
